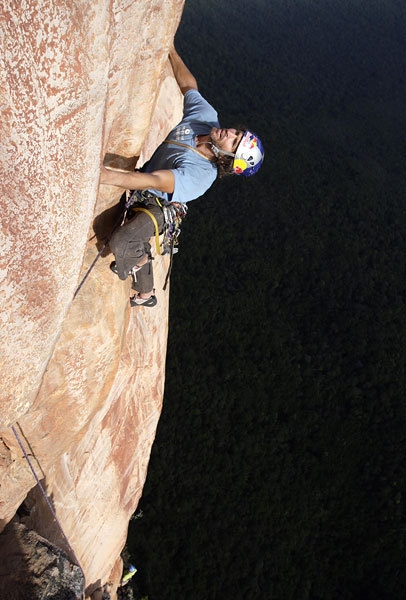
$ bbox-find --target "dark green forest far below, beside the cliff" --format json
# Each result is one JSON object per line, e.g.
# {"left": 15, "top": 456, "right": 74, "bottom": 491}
{"left": 127, "top": 0, "right": 406, "bottom": 600}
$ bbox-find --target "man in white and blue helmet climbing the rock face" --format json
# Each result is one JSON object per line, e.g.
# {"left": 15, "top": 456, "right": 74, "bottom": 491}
{"left": 100, "top": 47, "right": 264, "bottom": 306}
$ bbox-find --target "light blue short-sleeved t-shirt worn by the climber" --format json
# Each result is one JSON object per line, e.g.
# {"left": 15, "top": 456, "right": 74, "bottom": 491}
{"left": 142, "top": 90, "right": 220, "bottom": 202}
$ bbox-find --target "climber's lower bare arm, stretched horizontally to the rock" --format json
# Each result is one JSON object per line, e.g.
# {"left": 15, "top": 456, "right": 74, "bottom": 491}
{"left": 100, "top": 167, "right": 175, "bottom": 194}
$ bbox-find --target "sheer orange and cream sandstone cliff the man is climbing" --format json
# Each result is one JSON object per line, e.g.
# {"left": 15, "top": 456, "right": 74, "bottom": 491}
{"left": 0, "top": 0, "right": 184, "bottom": 593}
